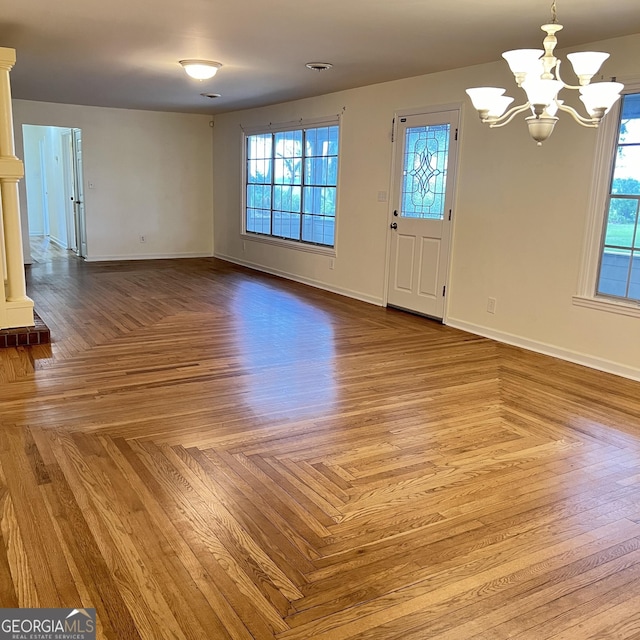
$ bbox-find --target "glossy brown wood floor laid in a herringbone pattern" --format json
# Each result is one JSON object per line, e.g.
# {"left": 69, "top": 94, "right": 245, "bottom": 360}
{"left": 0, "top": 259, "right": 640, "bottom": 640}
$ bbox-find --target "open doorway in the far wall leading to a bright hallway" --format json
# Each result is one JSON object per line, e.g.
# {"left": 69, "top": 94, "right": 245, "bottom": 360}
{"left": 22, "top": 124, "right": 87, "bottom": 262}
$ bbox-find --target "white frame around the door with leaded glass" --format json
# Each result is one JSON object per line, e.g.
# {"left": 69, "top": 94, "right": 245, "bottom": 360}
{"left": 382, "top": 102, "right": 464, "bottom": 324}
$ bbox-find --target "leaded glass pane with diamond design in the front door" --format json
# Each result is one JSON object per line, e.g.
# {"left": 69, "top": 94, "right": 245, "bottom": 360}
{"left": 400, "top": 124, "right": 451, "bottom": 220}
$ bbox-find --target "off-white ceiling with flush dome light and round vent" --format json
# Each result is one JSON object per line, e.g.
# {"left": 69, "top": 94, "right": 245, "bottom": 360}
{"left": 0, "top": 0, "right": 640, "bottom": 114}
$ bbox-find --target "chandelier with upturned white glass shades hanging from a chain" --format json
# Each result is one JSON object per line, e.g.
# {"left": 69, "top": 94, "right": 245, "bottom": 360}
{"left": 467, "top": 0, "right": 624, "bottom": 146}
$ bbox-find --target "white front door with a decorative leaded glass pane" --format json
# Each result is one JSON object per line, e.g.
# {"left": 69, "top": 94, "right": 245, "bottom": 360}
{"left": 387, "top": 110, "right": 459, "bottom": 320}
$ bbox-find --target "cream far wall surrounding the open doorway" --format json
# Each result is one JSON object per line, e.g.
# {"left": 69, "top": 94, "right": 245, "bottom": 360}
{"left": 13, "top": 100, "right": 213, "bottom": 260}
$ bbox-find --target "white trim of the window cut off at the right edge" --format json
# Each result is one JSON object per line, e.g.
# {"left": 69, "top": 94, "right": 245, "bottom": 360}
{"left": 573, "top": 78, "right": 640, "bottom": 318}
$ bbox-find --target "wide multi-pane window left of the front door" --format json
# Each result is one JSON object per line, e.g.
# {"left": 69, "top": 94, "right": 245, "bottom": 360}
{"left": 245, "top": 124, "right": 339, "bottom": 247}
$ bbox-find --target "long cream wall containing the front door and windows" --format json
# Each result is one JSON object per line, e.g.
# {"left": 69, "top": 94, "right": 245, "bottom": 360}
{"left": 213, "top": 34, "right": 640, "bottom": 379}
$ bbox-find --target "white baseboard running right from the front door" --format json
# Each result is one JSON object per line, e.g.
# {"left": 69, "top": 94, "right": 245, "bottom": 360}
{"left": 447, "top": 318, "right": 640, "bottom": 381}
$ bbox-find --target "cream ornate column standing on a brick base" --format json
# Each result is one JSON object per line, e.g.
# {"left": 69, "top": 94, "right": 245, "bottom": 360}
{"left": 0, "top": 47, "right": 34, "bottom": 329}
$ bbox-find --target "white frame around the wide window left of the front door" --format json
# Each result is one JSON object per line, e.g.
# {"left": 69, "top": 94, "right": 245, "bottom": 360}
{"left": 240, "top": 115, "right": 342, "bottom": 257}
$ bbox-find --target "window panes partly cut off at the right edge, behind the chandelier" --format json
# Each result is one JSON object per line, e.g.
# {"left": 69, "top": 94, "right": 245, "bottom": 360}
{"left": 596, "top": 93, "right": 640, "bottom": 302}
